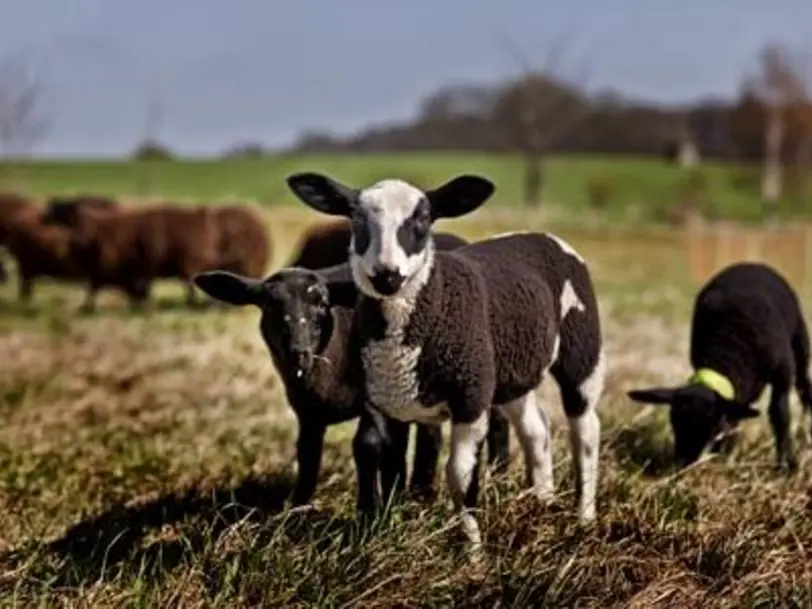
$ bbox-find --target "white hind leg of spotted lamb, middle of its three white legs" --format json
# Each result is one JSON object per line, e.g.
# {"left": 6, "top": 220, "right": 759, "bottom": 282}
{"left": 501, "top": 391, "right": 554, "bottom": 501}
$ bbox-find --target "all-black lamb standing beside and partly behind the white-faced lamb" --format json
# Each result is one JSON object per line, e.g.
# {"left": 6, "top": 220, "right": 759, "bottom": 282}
{"left": 194, "top": 233, "right": 507, "bottom": 512}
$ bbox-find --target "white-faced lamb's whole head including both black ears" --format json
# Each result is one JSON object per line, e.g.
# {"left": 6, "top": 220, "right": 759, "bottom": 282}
{"left": 287, "top": 173, "right": 495, "bottom": 299}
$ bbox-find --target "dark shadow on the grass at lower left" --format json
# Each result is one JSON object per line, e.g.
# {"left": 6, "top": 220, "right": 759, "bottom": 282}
{"left": 0, "top": 475, "right": 354, "bottom": 589}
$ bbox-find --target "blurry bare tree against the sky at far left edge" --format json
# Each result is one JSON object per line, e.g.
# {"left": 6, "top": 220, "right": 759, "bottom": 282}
{"left": 0, "top": 53, "right": 49, "bottom": 158}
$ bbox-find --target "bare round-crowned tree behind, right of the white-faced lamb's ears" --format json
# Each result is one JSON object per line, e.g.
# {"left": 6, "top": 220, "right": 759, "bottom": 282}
{"left": 494, "top": 33, "right": 590, "bottom": 206}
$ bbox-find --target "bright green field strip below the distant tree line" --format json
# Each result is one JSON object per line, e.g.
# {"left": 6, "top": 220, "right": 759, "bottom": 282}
{"left": 0, "top": 153, "right": 800, "bottom": 222}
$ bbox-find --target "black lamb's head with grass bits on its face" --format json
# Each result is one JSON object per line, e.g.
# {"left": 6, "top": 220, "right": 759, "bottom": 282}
{"left": 194, "top": 268, "right": 333, "bottom": 376}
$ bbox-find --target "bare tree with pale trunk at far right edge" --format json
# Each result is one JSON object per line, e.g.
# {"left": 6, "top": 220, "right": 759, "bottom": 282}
{"left": 747, "top": 44, "right": 810, "bottom": 212}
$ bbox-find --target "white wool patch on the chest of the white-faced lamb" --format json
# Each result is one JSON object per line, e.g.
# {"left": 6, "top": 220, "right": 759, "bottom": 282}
{"left": 361, "top": 245, "right": 440, "bottom": 423}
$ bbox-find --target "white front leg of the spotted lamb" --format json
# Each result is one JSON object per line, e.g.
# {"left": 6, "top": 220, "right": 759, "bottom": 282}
{"left": 446, "top": 410, "right": 488, "bottom": 550}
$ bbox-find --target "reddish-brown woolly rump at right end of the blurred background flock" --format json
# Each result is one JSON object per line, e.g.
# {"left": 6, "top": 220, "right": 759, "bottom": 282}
{"left": 211, "top": 204, "right": 272, "bottom": 277}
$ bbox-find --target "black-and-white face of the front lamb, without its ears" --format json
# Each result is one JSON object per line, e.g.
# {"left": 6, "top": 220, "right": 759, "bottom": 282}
{"left": 350, "top": 180, "right": 434, "bottom": 298}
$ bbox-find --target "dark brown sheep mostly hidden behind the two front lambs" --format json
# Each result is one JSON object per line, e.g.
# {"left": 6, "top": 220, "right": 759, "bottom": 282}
{"left": 286, "top": 218, "right": 510, "bottom": 473}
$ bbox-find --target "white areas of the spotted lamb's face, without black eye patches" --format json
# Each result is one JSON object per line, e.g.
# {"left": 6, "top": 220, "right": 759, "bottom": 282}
{"left": 350, "top": 180, "right": 434, "bottom": 299}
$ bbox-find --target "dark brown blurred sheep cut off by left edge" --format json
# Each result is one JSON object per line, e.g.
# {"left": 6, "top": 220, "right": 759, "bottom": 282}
{"left": 0, "top": 194, "right": 81, "bottom": 304}
